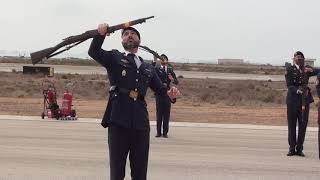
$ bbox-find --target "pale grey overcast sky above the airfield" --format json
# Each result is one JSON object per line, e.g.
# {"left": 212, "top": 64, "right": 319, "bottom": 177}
{"left": 0, "top": 0, "right": 320, "bottom": 64}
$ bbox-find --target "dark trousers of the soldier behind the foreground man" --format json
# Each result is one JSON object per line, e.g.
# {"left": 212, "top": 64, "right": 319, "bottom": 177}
{"left": 156, "top": 96, "right": 171, "bottom": 134}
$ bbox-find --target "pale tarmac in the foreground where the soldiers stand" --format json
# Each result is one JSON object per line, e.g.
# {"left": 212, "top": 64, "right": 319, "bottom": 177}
{"left": 0, "top": 115, "right": 320, "bottom": 180}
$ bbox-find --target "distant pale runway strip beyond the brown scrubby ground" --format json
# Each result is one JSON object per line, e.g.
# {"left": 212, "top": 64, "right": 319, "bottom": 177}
{"left": 0, "top": 63, "right": 285, "bottom": 81}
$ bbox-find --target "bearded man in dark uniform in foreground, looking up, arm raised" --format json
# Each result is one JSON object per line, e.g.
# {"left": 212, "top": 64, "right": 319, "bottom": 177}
{"left": 88, "top": 24, "right": 180, "bottom": 180}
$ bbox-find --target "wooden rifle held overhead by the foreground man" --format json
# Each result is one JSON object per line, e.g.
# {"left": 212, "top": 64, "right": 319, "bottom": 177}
{"left": 30, "top": 16, "right": 154, "bottom": 64}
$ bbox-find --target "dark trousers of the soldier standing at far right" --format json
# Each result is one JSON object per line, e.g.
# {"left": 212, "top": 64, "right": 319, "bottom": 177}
{"left": 287, "top": 104, "right": 309, "bottom": 151}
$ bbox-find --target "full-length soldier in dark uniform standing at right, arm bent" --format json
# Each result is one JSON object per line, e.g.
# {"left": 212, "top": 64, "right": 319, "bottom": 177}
{"left": 285, "top": 51, "right": 319, "bottom": 156}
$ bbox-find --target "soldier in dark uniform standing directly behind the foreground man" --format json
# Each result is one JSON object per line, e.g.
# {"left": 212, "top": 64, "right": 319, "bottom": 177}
{"left": 152, "top": 54, "right": 179, "bottom": 138}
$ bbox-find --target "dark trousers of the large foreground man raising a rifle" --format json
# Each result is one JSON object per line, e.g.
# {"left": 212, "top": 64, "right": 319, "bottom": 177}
{"left": 108, "top": 125, "right": 150, "bottom": 180}
